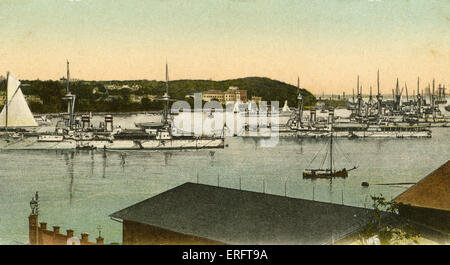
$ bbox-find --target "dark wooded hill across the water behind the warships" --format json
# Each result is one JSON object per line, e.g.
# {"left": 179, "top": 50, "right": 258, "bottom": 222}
{"left": 0, "top": 77, "right": 316, "bottom": 113}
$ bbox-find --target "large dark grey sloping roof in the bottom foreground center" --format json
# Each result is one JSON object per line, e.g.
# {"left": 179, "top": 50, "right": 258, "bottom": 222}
{"left": 110, "top": 183, "right": 372, "bottom": 244}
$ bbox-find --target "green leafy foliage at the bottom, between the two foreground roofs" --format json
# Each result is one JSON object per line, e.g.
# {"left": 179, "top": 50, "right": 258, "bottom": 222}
{"left": 359, "top": 194, "right": 420, "bottom": 245}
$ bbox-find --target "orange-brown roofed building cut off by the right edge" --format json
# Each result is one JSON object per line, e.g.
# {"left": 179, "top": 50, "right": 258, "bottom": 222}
{"left": 394, "top": 161, "right": 450, "bottom": 233}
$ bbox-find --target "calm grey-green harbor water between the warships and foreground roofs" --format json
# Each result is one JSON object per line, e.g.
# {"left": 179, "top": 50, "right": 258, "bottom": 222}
{"left": 0, "top": 111, "right": 450, "bottom": 244}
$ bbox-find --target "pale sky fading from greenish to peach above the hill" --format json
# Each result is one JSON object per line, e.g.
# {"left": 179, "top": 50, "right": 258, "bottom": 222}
{"left": 0, "top": 0, "right": 450, "bottom": 95}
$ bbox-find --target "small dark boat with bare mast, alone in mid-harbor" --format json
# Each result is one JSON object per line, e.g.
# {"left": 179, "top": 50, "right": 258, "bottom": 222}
{"left": 303, "top": 132, "right": 357, "bottom": 178}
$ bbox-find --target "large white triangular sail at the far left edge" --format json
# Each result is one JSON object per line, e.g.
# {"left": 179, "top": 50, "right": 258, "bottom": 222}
{"left": 0, "top": 73, "right": 38, "bottom": 127}
